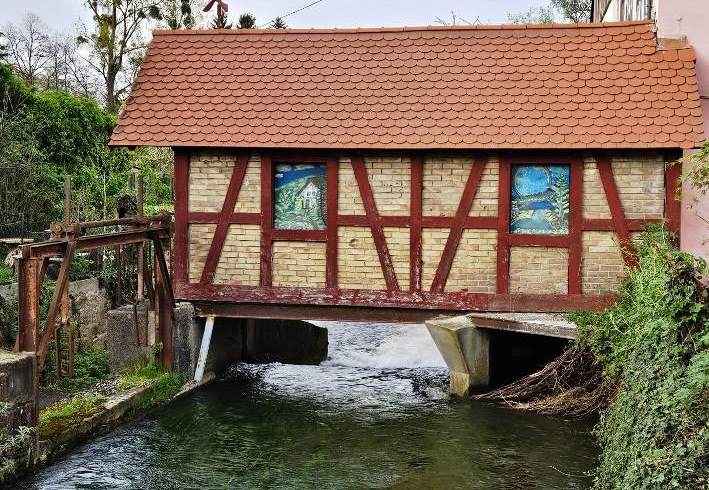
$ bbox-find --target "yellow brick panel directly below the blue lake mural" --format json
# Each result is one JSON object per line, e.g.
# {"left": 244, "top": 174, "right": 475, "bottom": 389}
{"left": 510, "top": 247, "right": 569, "bottom": 294}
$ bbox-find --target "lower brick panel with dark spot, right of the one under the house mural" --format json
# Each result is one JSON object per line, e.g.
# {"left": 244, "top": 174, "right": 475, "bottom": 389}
{"left": 337, "top": 226, "right": 386, "bottom": 289}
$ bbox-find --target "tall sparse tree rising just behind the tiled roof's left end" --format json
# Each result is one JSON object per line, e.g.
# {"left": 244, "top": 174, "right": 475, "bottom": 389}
{"left": 78, "top": 0, "right": 161, "bottom": 114}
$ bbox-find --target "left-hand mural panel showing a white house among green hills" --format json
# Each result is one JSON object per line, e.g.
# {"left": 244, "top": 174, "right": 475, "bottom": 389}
{"left": 273, "top": 164, "right": 327, "bottom": 230}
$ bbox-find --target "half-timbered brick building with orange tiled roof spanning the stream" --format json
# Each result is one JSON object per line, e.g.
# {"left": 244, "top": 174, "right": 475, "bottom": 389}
{"left": 111, "top": 22, "right": 704, "bottom": 320}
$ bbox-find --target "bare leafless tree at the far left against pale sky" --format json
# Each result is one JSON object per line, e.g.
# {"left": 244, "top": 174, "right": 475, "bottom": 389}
{"left": 5, "top": 13, "right": 49, "bottom": 85}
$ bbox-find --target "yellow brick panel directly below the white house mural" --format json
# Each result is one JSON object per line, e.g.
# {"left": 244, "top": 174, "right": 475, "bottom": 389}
{"left": 273, "top": 242, "right": 325, "bottom": 288}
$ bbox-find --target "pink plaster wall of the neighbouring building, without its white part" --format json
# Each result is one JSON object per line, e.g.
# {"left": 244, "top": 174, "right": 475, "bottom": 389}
{"left": 657, "top": 0, "right": 709, "bottom": 260}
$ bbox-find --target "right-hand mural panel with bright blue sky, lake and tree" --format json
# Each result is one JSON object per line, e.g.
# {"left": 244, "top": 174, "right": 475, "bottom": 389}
{"left": 510, "top": 165, "right": 569, "bottom": 235}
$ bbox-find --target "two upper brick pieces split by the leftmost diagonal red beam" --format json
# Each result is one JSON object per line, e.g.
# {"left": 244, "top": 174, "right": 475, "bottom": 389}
{"left": 189, "top": 151, "right": 261, "bottom": 213}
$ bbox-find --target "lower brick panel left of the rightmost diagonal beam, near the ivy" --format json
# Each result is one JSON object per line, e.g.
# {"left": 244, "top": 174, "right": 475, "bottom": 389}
{"left": 581, "top": 231, "right": 626, "bottom": 294}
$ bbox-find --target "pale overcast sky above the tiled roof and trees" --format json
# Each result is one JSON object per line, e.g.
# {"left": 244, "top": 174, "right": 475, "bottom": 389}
{"left": 0, "top": 0, "right": 548, "bottom": 34}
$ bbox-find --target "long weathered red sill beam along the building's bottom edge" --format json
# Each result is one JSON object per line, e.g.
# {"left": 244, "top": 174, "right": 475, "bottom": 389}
{"left": 176, "top": 284, "right": 616, "bottom": 312}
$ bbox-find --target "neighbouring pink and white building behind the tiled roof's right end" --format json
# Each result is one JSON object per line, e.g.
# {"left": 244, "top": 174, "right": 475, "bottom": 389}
{"left": 593, "top": 0, "right": 709, "bottom": 260}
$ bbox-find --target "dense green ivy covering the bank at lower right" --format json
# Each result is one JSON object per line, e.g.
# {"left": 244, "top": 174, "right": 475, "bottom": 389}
{"left": 573, "top": 228, "right": 709, "bottom": 489}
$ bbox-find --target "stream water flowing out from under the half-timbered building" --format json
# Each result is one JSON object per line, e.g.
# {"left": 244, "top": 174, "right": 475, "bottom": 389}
{"left": 22, "top": 323, "right": 596, "bottom": 490}
